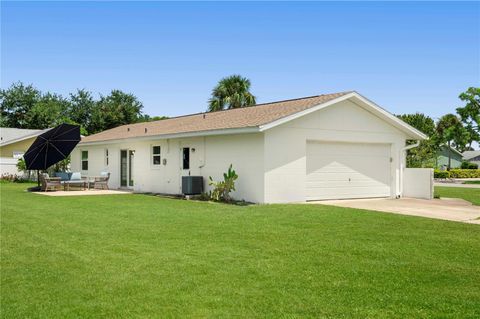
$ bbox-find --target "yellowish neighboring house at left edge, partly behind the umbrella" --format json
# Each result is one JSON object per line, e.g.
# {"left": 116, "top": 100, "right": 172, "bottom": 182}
{"left": 0, "top": 127, "right": 46, "bottom": 175}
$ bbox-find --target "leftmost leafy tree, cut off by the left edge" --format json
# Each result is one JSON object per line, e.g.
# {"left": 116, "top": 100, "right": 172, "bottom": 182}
{"left": 0, "top": 82, "right": 41, "bottom": 128}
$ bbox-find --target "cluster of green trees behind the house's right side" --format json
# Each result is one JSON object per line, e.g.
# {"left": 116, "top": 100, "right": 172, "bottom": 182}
{"left": 397, "top": 87, "right": 480, "bottom": 169}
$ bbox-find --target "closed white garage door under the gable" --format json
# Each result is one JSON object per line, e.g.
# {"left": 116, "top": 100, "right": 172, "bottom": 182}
{"left": 307, "top": 142, "right": 391, "bottom": 200}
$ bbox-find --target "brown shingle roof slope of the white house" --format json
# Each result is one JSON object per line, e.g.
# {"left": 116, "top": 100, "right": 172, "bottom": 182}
{"left": 81, "top": 92, "right": 350, "bottom": 143}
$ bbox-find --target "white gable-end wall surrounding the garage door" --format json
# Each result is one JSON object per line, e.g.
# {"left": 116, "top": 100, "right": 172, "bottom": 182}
{"left": 264, "top": 101, "right": 406, "bottom": 203}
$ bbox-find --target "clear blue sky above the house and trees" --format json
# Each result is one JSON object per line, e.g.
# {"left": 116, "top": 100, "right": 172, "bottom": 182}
{"left": 1, "top": 1, "right": 480, "bottom": 117}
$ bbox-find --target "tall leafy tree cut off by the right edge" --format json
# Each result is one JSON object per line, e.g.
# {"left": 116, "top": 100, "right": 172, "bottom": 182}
{"left": 457, "top": 87, "right": 480, "bottom": 148}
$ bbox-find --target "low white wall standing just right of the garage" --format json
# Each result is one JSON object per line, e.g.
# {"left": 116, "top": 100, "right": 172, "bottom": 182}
{"left": 403, "top": 168, "right": 433, "bottom": 199}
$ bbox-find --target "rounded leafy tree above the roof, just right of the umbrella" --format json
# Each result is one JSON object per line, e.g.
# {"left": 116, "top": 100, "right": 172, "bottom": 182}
{"left": 88, "top": 90, "right": 143, "bottom": 133}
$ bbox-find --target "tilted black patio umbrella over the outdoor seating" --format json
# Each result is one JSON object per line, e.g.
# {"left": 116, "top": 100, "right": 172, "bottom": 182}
{"left": 23, "top": 124, "right": 80, "bottom": 185}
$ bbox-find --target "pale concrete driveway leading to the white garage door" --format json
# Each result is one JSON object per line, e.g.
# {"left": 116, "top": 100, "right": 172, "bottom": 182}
{"left": 311, "top": 198, "right": 480, "bottom": 224}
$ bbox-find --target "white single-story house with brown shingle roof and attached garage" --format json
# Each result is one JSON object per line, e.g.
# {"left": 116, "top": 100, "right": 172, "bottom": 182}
{"left": 71, "top": 92, "right": 426, "bottom": 203}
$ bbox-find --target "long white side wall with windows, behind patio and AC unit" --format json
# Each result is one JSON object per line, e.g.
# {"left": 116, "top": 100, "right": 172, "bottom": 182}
{"left": 71, "top": 133, "right": 264, "bottom": 203}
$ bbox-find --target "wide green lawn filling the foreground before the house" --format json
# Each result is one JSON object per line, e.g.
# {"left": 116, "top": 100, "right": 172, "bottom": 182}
{"left": 0, "top": 184, "right": 480, "bottom": 318}
